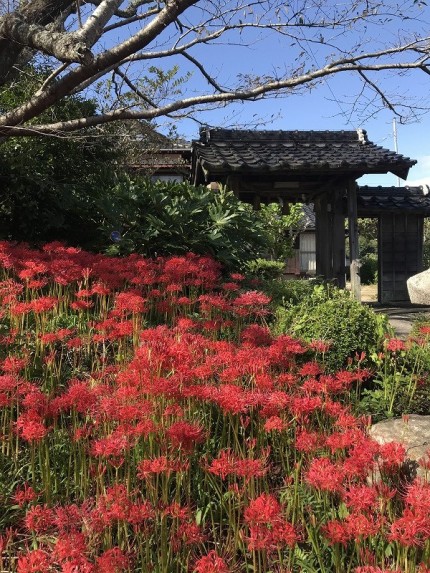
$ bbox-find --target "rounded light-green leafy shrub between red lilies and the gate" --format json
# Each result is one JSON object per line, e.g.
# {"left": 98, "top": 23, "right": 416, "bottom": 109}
{"left": 274, "top": 284, "right": 388, "bottom": 370}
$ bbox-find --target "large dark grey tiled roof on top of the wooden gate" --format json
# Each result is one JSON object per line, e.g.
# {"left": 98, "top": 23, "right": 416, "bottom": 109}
{"left": 193, "top": 128, "right": 416, "bottom": 178}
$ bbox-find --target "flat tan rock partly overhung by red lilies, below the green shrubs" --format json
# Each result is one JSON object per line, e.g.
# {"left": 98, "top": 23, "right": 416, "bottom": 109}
{"left": 370, "top": 414, "right": 430, "bottom": 479}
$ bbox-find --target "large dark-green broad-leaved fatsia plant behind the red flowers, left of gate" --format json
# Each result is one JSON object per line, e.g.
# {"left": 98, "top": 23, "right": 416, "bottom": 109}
{"left": 103, "top": 178, "right": 265, "bottom": 268}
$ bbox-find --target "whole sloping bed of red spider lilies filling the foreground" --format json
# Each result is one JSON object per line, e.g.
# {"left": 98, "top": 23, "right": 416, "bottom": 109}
{"left": 0, "top": 243, "right": 430, "bottom": 573}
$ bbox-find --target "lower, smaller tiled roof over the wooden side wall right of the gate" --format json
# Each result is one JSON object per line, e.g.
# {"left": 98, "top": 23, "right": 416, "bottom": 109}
{"left": 357, "top": 186, "right": 430, "bottom": 215}
